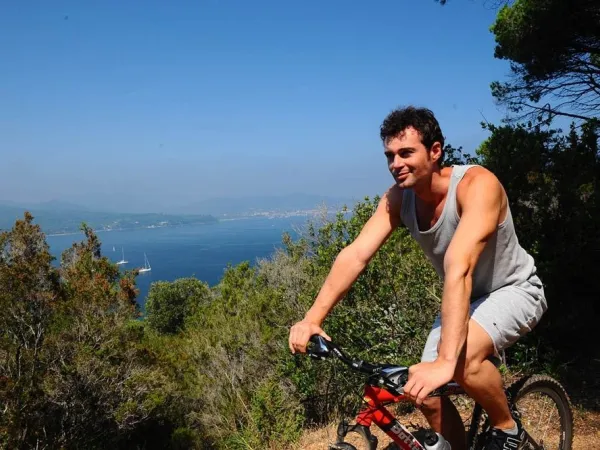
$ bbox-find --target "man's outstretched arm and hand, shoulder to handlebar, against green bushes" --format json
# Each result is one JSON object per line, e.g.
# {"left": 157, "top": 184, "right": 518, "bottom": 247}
{"left": 289, "top": 186, "right": 402, "bottom": 353}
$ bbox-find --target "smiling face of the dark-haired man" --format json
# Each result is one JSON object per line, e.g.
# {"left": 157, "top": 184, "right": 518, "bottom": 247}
{"left": 384, "top": 126, "right": 442, "bottom": 189}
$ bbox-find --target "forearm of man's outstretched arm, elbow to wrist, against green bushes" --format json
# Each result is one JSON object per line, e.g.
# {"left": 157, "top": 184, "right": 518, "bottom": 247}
{"left": 304, "top": 246, "right": 366, "bottom": 326}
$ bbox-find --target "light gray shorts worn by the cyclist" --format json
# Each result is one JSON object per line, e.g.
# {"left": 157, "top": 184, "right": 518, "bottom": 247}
{"left": 421, "top": 275, "right": 548, "bottom": 364}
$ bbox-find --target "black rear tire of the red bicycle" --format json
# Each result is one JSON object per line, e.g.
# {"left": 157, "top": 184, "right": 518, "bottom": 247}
{"left": 476, "top": 375, "right": 573, "bottom": 450}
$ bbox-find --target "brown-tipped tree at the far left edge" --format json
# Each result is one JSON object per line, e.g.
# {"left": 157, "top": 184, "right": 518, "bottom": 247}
{"left": 0, "top": 212, "right": 61, "bottom": 448}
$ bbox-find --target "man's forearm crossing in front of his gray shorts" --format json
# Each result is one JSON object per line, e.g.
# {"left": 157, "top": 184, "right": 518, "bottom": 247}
{"left": 438, "top": 271, "right": 472, "bottom": 364}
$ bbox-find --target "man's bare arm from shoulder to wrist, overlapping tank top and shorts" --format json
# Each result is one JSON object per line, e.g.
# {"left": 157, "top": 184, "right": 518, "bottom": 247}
{"left": 438, "top": 169, "right": 504, "bottom": 367}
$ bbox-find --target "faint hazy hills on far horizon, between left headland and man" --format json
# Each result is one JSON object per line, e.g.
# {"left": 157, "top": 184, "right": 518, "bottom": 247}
{"left": 185, "top": 194, "right": 355, "bottom": 215}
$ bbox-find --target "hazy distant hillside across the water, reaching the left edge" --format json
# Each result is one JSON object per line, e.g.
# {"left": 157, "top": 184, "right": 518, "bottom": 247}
{"left": 0, "top": 202, "right": 217, "bottom": 234}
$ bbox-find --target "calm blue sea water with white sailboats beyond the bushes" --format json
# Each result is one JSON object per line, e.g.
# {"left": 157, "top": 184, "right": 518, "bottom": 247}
{"left": 47, "top": 217, "right": 307, "bottom": 308}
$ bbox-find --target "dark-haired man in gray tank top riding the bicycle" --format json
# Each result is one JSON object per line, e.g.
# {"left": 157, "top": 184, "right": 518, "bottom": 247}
{"left": 289, "top": 107, "right": 547, "bottom": 450}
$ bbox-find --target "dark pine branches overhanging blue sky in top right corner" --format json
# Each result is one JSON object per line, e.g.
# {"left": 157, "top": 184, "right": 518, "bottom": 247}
{"left": 491, "top": 0, "right": 600, "bottom": 122}
